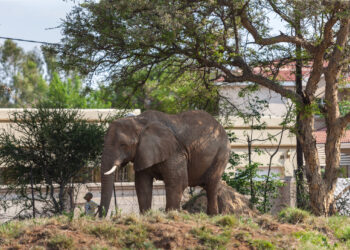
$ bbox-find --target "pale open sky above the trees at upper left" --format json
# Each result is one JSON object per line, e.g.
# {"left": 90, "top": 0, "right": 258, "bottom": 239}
{"left": 0, "top": 0, "right": 73, "bottom": 50}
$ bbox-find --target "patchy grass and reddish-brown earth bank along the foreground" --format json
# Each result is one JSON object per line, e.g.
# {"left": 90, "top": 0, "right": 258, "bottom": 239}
{"left": 0, "top": 209, "right": 350, "bottom": 250}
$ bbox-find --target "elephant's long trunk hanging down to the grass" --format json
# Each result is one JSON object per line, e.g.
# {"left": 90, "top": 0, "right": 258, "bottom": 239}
{"left": 99, "top": 150, "right": 119, "bottom": 217}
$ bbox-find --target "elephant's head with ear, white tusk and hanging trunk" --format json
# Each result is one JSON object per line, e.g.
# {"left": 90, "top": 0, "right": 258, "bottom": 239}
{"left": 100, "top": 116, "right": 178, "bottom": 216}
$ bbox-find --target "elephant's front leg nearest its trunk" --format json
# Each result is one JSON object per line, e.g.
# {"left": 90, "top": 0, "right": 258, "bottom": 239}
{"left": 135, "top": 171, "right": 153, "bottom": 213}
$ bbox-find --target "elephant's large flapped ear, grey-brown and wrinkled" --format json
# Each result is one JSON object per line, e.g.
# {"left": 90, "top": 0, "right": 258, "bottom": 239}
{"left": 134, "top": 122, "right": 179, "bottom": 171}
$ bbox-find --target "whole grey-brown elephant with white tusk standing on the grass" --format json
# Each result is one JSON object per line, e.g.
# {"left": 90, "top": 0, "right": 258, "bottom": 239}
{"left": 100, "top": 111, "right": 230, "bottom": 216}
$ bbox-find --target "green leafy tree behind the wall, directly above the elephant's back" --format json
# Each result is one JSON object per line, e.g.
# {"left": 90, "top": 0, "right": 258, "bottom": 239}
{"left": 109, "top": 64, "right": 218, "bottom": 114}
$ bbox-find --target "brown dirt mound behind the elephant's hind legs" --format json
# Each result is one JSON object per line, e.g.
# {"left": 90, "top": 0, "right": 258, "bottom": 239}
{"left": 182, "top": 182, "right": 258, "bottom": 216}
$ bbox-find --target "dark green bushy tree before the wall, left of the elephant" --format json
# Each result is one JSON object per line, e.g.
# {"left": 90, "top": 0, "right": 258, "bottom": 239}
{"left": 0, "top": 107, "right": 105, "bottom": 215}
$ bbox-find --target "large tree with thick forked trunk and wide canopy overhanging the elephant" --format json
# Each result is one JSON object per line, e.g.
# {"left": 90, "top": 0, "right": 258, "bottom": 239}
{"left": 56, "top": 0, "right": 350, "bottom": 215}
